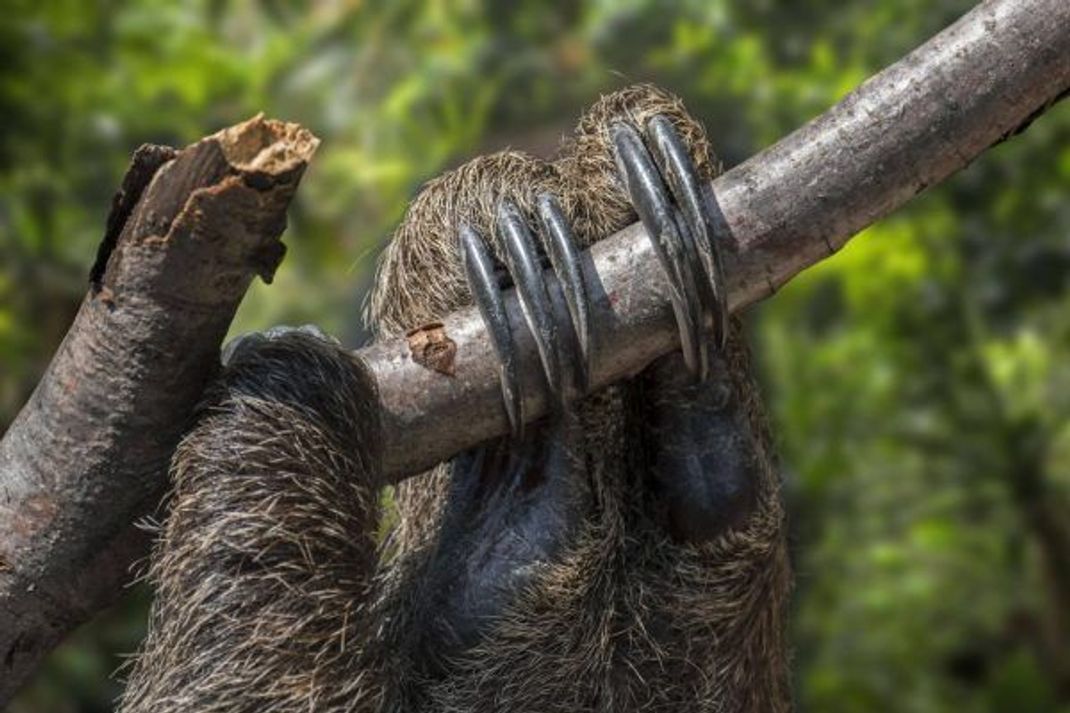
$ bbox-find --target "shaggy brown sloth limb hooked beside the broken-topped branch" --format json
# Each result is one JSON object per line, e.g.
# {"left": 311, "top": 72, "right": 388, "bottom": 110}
{"left": 119, "top": 330, "right": 384, "bottom": 713}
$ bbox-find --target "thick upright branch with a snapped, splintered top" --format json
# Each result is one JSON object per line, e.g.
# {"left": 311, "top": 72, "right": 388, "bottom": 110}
{"left": 0, "top": 117, "right": 317, "bottom": 703}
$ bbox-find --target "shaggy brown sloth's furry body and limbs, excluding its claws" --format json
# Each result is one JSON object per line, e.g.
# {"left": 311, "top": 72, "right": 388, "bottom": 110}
{"left": 120, "top": 86, "right": 791, "bottom": 713}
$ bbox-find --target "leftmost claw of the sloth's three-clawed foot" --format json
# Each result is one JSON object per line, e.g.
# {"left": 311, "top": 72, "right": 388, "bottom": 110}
{"left": 459, "top": 225, "right": 524, "bottom": 439}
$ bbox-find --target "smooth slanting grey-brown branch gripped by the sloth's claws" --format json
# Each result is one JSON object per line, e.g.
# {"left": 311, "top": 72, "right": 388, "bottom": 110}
{"left": 356, "top": 0, "right": 1070, "bottom": 480}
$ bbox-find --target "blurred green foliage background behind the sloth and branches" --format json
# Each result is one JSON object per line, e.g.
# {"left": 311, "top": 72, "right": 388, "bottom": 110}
{"left": 0, "top": 0, "right": 1070, "bottom": 713}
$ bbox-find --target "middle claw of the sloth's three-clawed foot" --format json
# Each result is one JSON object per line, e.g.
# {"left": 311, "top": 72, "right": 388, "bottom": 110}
{"left": 498, "top": 199, "right": 565, "bottom": 403}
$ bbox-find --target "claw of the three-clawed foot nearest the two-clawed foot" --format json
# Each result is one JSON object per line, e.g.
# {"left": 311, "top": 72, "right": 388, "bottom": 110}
{"left": 538, "top": 194, "right": 591, "bottom": 394}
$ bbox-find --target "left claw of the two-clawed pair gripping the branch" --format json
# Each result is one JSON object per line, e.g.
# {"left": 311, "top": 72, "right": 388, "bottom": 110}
{"left": 610, "top": 123, "right": 709, "bottom": 381}
